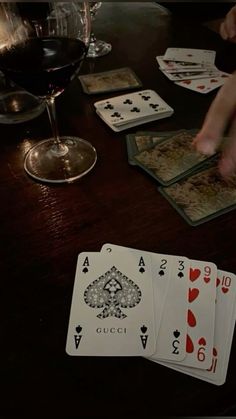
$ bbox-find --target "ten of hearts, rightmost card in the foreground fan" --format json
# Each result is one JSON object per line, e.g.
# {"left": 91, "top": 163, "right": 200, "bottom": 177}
{"left": 155, "top": 271, "right": 236, "bottom": 385}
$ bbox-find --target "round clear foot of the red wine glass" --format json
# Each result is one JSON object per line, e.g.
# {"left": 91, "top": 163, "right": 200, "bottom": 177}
{"left": 24, "top": 137, "right": 97, "bottom": 183}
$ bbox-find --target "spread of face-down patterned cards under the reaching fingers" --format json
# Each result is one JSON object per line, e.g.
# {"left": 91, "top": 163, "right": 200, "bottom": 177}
{"left": 126, "top": 129, "right": 236, "bottom": 226}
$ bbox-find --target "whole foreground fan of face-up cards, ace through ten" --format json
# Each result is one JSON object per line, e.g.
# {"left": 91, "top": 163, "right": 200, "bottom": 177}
{"left": 66, "top": 244, "right": 236, "bottom": 385}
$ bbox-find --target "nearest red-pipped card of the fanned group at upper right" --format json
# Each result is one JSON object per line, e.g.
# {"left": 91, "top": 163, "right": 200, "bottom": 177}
{"left": 175, "top": 71, "right": 229, "bottom": 94}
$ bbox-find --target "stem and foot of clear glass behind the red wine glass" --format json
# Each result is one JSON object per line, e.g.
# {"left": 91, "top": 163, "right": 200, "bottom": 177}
{"left": 87, "top": 1, "right": 112, "bottom": 58}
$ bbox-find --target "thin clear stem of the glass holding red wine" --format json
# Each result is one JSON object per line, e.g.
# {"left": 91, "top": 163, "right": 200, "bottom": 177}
{"left": 46, "top": 97, "right": 68, "bottom": 157}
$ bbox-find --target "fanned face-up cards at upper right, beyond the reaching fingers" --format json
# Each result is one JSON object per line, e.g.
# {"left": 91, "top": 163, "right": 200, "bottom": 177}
{"left": 156, "top": 48, "right": 229, "bottom": 93}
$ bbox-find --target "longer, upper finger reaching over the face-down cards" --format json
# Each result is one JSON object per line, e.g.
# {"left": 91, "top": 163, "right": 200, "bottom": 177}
{"left": 193, "top": 74, "right": 236, "bottom": 155}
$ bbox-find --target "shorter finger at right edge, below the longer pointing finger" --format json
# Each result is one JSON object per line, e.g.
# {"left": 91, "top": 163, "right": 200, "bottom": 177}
{"left": 219, "top": 115, "right": 236, "bottom": 178}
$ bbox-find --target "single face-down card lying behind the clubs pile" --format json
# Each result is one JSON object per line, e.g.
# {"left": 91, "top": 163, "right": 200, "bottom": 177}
{"left": 79, "top": 67, "right": 142, "bottom": 94}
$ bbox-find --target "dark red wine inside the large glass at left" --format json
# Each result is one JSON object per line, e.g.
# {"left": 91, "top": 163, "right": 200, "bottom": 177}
{"left": 0, "top": 37, "right": 87, "bottom": 97}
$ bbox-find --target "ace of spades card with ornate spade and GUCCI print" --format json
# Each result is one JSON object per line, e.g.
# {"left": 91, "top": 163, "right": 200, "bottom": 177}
{"left": 66, "top": 252, "right": 156, "bottom": 356}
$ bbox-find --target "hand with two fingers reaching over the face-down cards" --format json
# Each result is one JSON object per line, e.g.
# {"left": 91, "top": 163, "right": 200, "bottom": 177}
{"left": 193, "top": 72, "right": 236, "bottom": 178}
